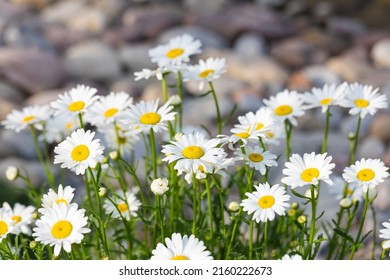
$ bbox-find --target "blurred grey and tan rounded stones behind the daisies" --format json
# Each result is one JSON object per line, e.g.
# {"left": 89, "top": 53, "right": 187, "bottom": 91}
{"left": 0, "top": 0, "right": 390, "bottom": 255}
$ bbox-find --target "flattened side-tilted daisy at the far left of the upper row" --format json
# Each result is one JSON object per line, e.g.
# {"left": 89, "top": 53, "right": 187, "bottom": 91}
{"left": 1, "top": 105, "right": 53, "bottom": 132}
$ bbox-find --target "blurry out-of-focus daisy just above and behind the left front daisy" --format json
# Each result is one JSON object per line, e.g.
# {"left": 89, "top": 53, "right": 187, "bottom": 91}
{"left": 39, "top": 115, "right": 80, "bottom": 143}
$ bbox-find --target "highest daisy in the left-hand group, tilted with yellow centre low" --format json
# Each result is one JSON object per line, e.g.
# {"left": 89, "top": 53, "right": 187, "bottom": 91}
{"left": 51, "top": 85, "right": 99, "bottom": 115}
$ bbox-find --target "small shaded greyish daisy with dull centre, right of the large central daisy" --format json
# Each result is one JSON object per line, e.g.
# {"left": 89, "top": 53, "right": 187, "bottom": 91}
{"left": 235, "top": 145, "right": 278, "bottom": 175}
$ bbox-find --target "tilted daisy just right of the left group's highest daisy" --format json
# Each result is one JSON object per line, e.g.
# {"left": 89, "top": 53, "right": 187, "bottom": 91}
{"left": 85, "top": 92, "right": 133, "bottom": 126}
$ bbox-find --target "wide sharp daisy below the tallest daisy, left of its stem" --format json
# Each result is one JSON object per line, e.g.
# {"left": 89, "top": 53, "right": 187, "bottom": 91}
{"left": 121, "top": 99, "right": 176, "bottom": 133}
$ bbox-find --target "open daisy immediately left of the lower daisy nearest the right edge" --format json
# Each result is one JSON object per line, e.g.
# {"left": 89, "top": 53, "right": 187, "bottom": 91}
{"left": 282, "top": 152, "right": 335, "bottom": 188}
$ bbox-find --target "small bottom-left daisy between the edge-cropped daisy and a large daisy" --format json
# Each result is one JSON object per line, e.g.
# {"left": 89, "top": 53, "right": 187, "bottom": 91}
{"left": 3, "top": 202, "right": 35, "bottom": 235}
